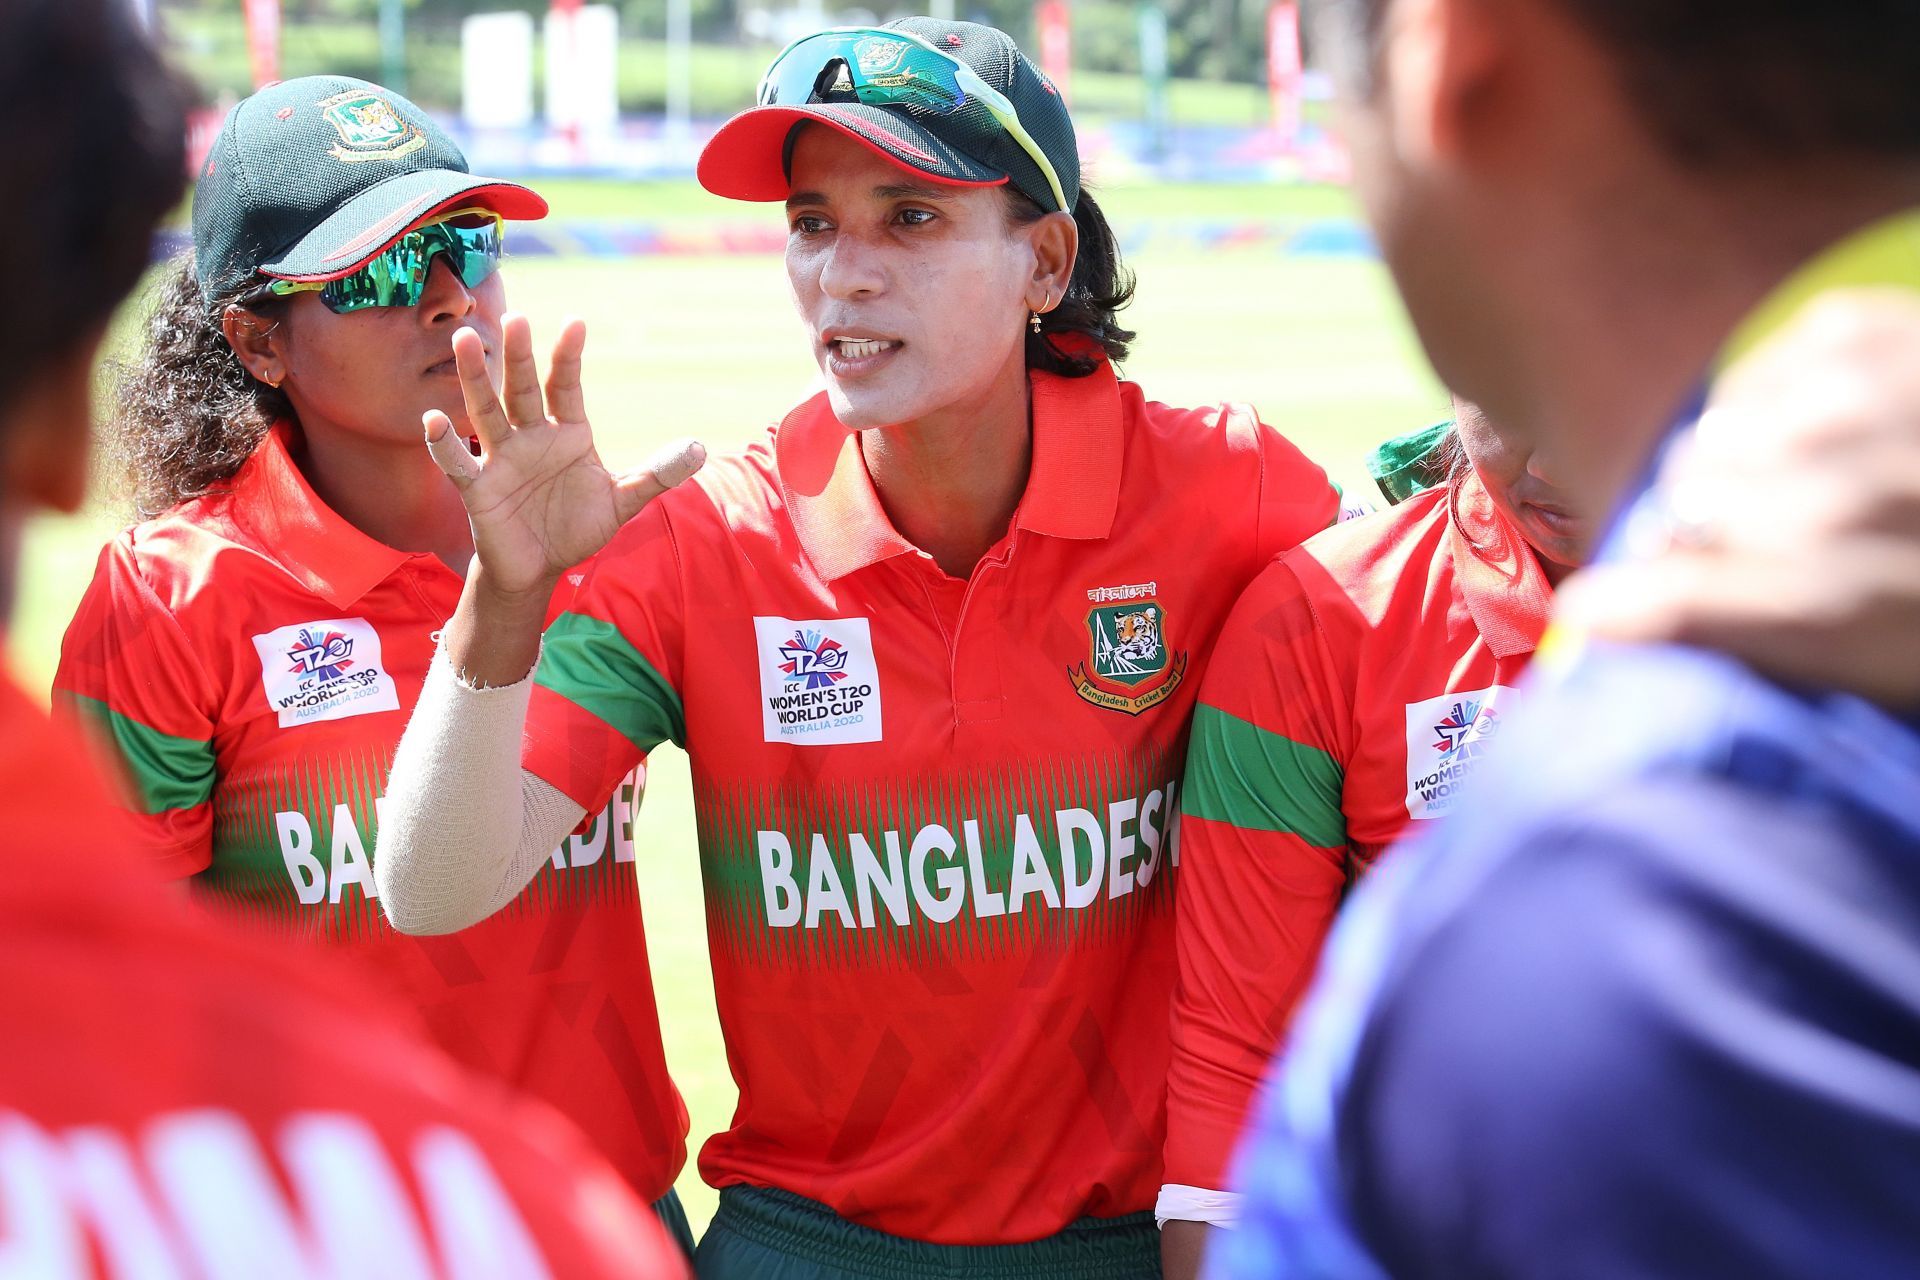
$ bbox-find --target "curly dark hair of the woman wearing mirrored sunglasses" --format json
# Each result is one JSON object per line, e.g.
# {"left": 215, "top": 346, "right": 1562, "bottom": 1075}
{"left": 108, "top": 251, "right": 294, "bottom": 518}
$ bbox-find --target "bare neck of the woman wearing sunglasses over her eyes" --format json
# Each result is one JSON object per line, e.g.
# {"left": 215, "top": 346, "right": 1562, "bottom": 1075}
{"left": 294, "top": 426, "right": 474, "bottom": 578}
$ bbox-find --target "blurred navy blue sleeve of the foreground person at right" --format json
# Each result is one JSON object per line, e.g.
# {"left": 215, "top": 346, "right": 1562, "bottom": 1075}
{"left": 1336, "top": 775, "right": 1920, "bottom": 1280}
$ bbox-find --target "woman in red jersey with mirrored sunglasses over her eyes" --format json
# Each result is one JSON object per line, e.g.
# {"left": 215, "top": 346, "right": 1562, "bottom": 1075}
{"left": 56, "top": 77, "right": 691, "bottom": 1249}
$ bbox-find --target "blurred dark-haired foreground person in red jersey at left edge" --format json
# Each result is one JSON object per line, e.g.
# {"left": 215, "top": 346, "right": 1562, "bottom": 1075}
{"left": 0, "top": 0, "right": 682, "bottom": 1280}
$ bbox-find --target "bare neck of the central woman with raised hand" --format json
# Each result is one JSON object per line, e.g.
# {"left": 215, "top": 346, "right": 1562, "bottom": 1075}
{"left": 860, "top": 349, "right": 1033, "bottom": 578}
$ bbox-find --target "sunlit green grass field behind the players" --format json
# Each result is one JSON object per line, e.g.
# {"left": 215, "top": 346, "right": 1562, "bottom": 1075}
{"left": 10, "top": 184, "right": 1446, "bottom": 1228}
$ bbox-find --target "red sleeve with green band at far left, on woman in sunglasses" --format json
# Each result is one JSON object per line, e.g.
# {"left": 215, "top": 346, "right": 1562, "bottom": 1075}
{"left": 54, "top": 533, "right": 219, "bottom": 877}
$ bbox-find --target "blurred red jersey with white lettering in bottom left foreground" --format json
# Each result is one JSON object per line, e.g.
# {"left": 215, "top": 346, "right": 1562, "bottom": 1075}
{"left": 0, "top": 676, "right": 685, "bottom": 1280}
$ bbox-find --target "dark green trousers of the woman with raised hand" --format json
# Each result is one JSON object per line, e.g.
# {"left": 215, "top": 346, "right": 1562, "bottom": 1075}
{"left": 693, "top": 1186, "right": 1160, "bottom": 1280}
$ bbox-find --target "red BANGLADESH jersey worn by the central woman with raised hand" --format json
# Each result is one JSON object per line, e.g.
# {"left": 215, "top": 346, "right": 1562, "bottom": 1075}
{"left": 524, "top": 363, "right": 1336, "bottom": 1244}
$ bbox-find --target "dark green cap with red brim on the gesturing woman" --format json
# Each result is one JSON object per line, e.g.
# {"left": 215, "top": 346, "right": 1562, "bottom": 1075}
{"left": 699, "top": 17, "right": 1079, "bottom": 211}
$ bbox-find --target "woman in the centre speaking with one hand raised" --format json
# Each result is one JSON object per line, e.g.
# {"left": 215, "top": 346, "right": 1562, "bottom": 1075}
{"left": 376, "top": 19, "right": 1338, "bottom": 1278}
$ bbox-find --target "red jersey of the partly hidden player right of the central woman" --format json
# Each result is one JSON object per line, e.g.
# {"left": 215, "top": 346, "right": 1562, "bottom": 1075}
{"left": 1167, "top": 470, "right": 1551, "bottom": 1188}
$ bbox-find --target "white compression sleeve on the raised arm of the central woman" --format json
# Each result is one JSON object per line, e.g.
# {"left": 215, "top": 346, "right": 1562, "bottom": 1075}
{"left": 372, "top": 651, "right": 586, "bottom": 933}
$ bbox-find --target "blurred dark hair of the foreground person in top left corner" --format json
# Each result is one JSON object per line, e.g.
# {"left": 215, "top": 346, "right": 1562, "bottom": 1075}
{"left": 0, "top": 0, "right": 186, "bottom": 430}
